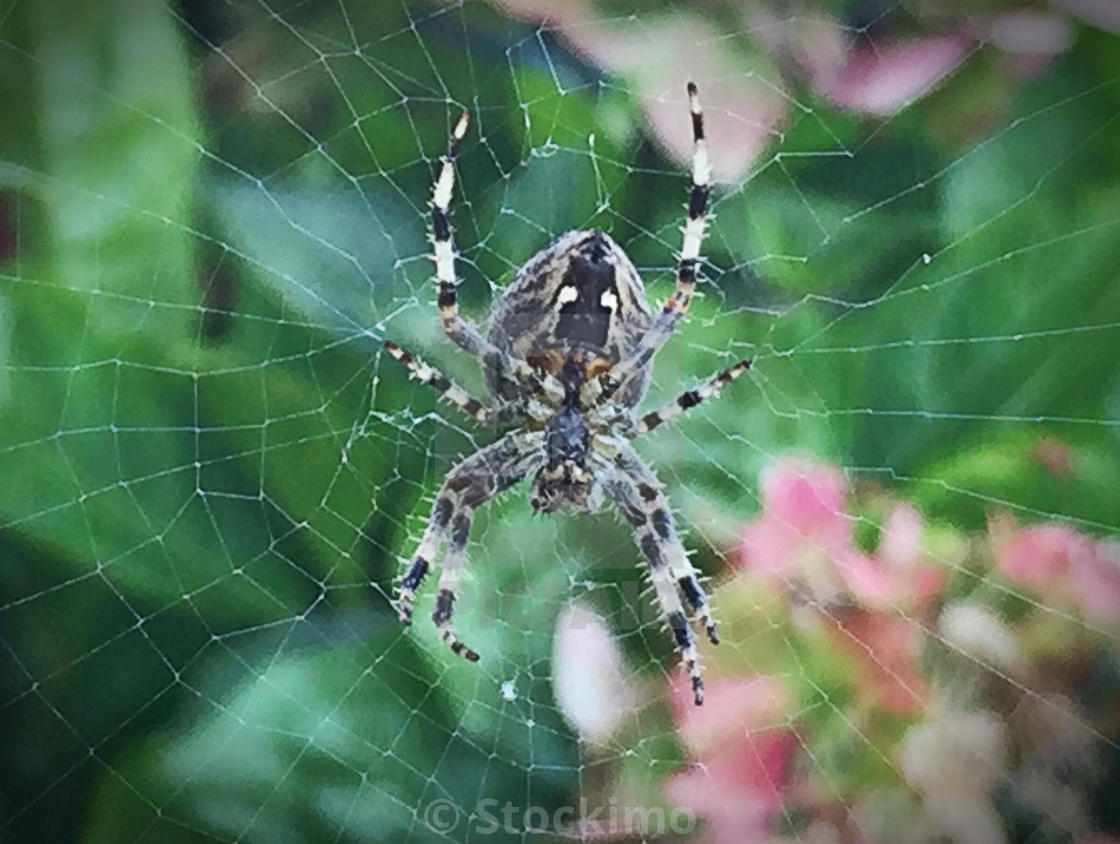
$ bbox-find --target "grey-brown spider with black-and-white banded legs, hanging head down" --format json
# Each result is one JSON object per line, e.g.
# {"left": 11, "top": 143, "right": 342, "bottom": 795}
{"left": 385, "top": 83, "right": 750, "bottom": 705}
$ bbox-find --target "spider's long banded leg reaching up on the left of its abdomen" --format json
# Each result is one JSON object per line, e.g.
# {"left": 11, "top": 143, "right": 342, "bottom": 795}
{"left": 431, "top": 111, "right": 563, "bottom": 402}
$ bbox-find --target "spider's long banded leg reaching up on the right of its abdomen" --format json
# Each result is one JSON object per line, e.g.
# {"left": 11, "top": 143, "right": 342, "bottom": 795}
{"left": 581, "top": 82, "right": 711, "bottom": 406}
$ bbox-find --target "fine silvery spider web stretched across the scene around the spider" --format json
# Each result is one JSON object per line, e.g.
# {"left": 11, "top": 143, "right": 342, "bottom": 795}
{"left": 0, "top": 0, "right": 1120, "bottom": 842}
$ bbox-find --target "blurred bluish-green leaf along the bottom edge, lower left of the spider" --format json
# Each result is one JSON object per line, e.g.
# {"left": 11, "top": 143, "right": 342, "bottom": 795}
{"left": 83, "top": 615, "right": 576, "bottom": 844}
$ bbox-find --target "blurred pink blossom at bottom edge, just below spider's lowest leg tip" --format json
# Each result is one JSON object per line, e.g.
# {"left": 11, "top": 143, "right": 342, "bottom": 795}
{"left": 664, "top": 676, "right": 799, "bottom": 844}
